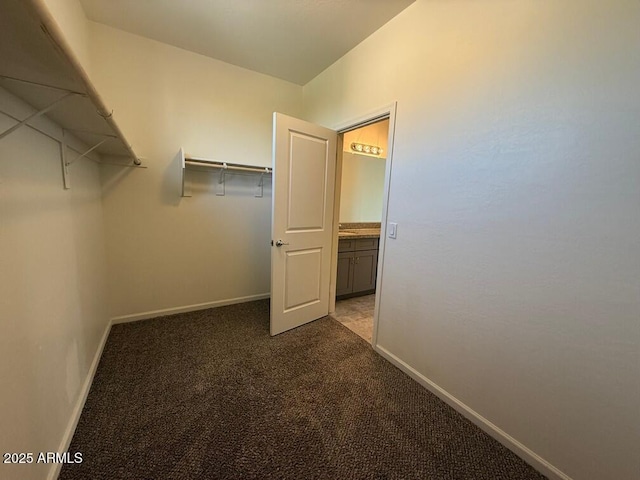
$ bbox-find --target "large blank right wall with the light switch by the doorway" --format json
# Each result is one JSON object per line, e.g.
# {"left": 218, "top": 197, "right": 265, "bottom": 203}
{"left": 304, "top": 0, "right": 640, "bottom": 480}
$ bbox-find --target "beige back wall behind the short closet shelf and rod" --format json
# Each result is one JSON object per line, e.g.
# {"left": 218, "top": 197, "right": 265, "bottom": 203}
{"left": 90, "top": 23, "right": 302, "bottom": 318}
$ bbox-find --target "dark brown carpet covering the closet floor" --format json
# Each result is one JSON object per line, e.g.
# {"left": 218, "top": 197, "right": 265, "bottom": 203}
{"left": 60, "top": 301, "right": 545, "bottom": 480}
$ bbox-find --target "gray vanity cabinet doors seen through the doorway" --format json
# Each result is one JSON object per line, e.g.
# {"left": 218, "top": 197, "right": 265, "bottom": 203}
{"left": 336, "top": 238, "right": 378, "bottom": 297}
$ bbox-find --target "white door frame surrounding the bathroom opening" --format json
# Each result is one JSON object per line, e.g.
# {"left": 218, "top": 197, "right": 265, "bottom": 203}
{"left": 329, "top": 102, "right": 398, "bottom": 348}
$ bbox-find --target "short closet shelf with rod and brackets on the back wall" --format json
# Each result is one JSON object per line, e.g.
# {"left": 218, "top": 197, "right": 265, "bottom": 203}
{"left": 178, "top": 148, "right": 273, "bottom": 197}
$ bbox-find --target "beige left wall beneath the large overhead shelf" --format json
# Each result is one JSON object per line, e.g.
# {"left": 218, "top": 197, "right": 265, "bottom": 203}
{"left": 0, "top": 89, "right": 108, "bottom": 479}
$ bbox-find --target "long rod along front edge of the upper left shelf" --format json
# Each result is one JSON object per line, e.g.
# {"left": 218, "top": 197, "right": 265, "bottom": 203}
{"left": 28, "top": 0, "right": 141, "bottom": 165}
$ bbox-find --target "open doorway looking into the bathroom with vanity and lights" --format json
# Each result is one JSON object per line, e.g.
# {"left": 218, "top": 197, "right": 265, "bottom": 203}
{"left": 330, "top": 105, "right": 395, "bottom": 346}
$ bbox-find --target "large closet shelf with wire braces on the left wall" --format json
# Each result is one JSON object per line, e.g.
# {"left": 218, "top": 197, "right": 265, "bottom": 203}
{"left": 0, "top": 0, "right": 141, "bottom": 188}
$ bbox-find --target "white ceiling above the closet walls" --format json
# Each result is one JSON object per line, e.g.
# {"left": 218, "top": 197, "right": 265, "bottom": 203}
{"left": 81, "top": 0, "right": 415, "bottom": 85}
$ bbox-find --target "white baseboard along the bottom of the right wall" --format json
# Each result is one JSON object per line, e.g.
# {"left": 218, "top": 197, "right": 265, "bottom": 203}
{"left": 373, "top": 345, "right": 572, "bottom": 480}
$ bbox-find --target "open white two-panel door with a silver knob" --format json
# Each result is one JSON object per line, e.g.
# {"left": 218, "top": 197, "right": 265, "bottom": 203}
{"left": 271, "top": 113, "right": 337, "bottom": 335}
